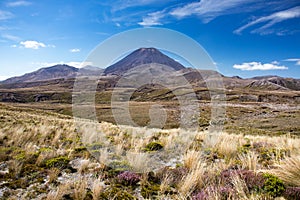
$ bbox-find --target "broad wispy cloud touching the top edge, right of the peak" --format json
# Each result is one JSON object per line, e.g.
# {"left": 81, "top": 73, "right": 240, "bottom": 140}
{"left": 170, "top": 0, "right": 251, "bottom": 23}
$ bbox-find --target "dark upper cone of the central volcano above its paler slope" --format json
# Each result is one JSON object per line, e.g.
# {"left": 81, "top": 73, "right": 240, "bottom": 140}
{"left": 104, "top": 48, "right": 185, "bottom": 75}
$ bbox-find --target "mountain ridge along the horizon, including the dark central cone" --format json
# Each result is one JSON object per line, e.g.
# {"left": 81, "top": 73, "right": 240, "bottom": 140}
{"left": 0, "top": 47, "right": 300, "bottom": 91}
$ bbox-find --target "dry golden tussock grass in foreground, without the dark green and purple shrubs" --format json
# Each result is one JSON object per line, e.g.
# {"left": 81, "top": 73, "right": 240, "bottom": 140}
{"left": 0, "top": 106, "right": 300, "bottom": 199}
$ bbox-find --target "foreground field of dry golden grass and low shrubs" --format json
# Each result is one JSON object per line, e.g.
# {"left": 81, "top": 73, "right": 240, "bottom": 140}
{"left": 0, "top": 104, "right": 300, "bottom": 200}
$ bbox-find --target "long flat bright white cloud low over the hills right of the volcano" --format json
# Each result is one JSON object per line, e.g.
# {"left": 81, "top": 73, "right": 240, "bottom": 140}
{"left": 233, "top": 61, "right": 288, "bottom": 71}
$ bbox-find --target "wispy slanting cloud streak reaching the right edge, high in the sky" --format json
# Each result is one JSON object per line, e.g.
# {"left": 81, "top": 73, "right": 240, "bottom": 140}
{"left": 234, "top": 6, "right": 300, "bottom": 34}
